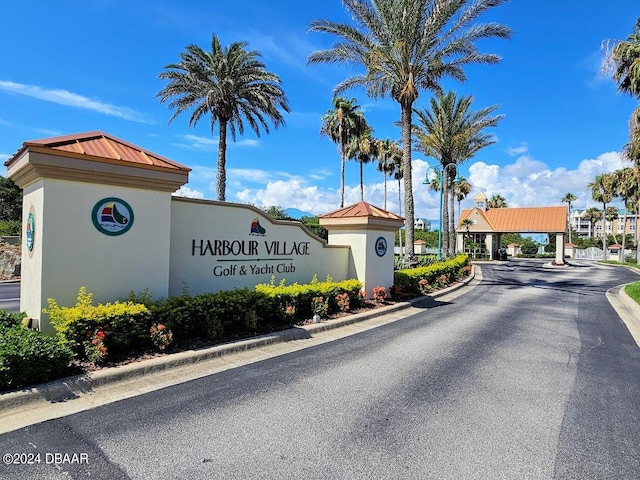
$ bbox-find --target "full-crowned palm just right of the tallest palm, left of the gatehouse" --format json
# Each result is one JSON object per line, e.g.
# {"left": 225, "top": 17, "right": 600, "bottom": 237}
{"left": 414, "top": 92, "right": 504, "bottom": 253}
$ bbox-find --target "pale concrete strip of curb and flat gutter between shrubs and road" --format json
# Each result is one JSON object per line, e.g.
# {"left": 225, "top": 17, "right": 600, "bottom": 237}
{"left": 0, "top": 266, "right": 482, "bottom": 434}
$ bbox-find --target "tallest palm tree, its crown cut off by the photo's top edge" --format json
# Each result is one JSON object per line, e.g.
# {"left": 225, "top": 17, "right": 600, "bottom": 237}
{"left": 308, "top": 0, "right": 511, "bottom": 257}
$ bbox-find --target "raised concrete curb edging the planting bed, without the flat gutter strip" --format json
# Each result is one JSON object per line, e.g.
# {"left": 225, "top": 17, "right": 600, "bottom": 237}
{"left": 0, "top": 266, "right": 481, "bottom": 416}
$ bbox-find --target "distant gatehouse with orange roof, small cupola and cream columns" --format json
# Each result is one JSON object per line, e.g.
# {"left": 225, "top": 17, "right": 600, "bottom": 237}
{"left": 456, "top": 192, "right": 567, "bottom": 265}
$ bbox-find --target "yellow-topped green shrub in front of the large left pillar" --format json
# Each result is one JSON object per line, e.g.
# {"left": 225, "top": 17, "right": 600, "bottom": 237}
{"left": 44, "top": 287, "right": 152, "bottom": 357}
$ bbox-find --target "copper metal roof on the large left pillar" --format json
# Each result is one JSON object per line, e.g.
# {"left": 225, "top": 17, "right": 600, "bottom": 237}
{"left": 5, "top": 131, "right": 191, "bottom": 172}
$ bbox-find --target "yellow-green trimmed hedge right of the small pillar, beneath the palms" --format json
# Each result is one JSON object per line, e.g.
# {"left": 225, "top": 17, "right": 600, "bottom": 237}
{"left": 393, "top": 254, "right": 471, "bottom": 297}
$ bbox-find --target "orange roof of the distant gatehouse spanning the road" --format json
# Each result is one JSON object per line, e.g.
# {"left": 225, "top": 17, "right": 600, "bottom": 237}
{"left": 458, "top": 206, "right": 567, "bottom": 233}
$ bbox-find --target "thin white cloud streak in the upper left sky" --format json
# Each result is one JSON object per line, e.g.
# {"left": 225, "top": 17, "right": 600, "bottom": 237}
{"left": 0, "top": 80, "right": 149, "bottom": 123}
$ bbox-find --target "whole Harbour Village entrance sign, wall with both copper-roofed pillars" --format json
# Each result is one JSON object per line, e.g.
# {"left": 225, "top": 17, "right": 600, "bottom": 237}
{"left": 5, "top": 131, "right": 404, "bottom": 333}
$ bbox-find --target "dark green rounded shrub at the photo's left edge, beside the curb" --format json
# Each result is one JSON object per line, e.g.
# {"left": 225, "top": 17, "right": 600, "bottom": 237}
{"left": 0, "top": 326, "right": 73, "bottom": 390}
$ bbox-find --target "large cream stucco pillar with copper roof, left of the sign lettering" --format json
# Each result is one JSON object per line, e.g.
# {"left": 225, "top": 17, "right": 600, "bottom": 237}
{"left": 5, "top": 132, "right": 190, "bottom": 333}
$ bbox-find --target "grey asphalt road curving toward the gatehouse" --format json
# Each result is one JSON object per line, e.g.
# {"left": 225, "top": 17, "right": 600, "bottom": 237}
{"left": 0, "top": 261, "right": 640, "bottom": 480}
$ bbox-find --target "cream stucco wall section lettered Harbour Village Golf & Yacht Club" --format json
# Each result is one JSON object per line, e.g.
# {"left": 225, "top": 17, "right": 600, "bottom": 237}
{"left": 169, "top": 197, "right": 350, "bottom": 295}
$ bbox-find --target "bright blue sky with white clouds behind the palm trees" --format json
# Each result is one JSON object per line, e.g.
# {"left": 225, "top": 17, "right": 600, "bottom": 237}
{"left": 0, "top": 0, "right": 640, "bottom": 223}
